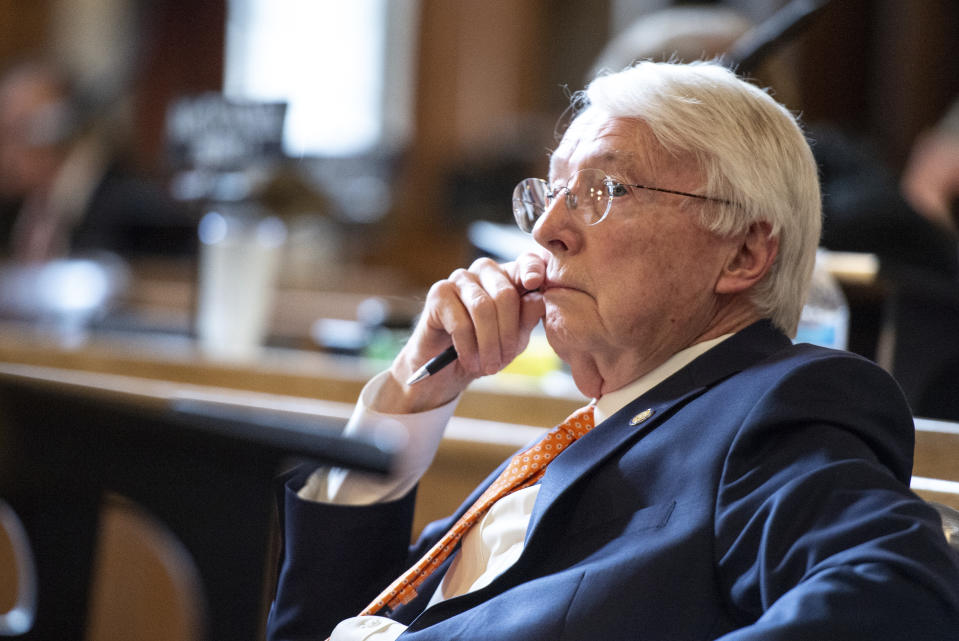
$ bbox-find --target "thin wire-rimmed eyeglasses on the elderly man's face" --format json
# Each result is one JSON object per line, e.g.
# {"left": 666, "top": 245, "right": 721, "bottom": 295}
{"left": 513, "top": 169, "right": 729, "bottom": 233}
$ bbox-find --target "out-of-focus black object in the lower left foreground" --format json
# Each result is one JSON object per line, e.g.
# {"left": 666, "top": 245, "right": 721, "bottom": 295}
{"left": 0, "top": 373, "right": 391, "bottom": 641}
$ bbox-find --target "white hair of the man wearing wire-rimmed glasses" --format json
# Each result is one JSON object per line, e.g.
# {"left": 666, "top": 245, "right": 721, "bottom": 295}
{"left": 573, "top": 62, "right": 822, "bottom": 336}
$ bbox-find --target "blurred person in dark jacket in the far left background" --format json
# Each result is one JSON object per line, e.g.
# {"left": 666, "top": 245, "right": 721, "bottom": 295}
{"left": 0, "top": 59, "right": 195, "bottom": 264}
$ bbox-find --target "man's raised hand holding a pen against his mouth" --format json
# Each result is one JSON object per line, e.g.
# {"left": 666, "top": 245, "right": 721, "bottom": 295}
{"left": 372, "top": 254, "right": 546, "bottom": 414}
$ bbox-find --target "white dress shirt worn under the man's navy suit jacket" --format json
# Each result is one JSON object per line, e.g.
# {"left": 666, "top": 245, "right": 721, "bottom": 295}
{"left": 298, "top": 334, "right": 731, "bottom": 641}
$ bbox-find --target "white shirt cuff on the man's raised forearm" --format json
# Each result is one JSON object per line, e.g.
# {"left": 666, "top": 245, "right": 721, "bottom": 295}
{"left": 297, "top": 372, "right": 459, "bottom": 505}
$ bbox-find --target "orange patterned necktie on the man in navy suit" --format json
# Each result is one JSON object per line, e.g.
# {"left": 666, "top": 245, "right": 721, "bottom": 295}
{"left": 359, "top": 404, "right": 593, "bottom": 616}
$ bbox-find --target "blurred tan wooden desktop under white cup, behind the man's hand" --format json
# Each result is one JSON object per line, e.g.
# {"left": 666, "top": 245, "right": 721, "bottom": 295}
{"left": 0, "top": 323, "right": 583, "bottom": 427}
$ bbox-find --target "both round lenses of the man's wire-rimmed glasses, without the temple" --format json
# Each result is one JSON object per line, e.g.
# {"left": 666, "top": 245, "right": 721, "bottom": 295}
{"left": 513, "top": 169, "right": 611, "bottom": 233}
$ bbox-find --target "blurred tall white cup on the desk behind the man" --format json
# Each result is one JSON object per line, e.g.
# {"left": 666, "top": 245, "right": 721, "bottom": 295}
{"left": 197, "top": 205, "right": 286, "bottom": 361}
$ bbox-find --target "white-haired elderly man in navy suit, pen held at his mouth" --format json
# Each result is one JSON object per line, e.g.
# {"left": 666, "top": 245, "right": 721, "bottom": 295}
{"left": 269, "top": 63, "right": 959, "bottom": 641}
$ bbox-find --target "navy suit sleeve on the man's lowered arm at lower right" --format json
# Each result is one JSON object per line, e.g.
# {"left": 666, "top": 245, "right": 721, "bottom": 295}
{"left": 715, "top": 357, "right": 959, "bottom": 641}
